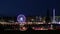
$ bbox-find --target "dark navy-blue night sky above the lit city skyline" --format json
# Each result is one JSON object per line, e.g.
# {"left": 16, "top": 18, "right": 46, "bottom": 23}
{"left": 0, "top": 0, "right": 60, "bottom": 16}
